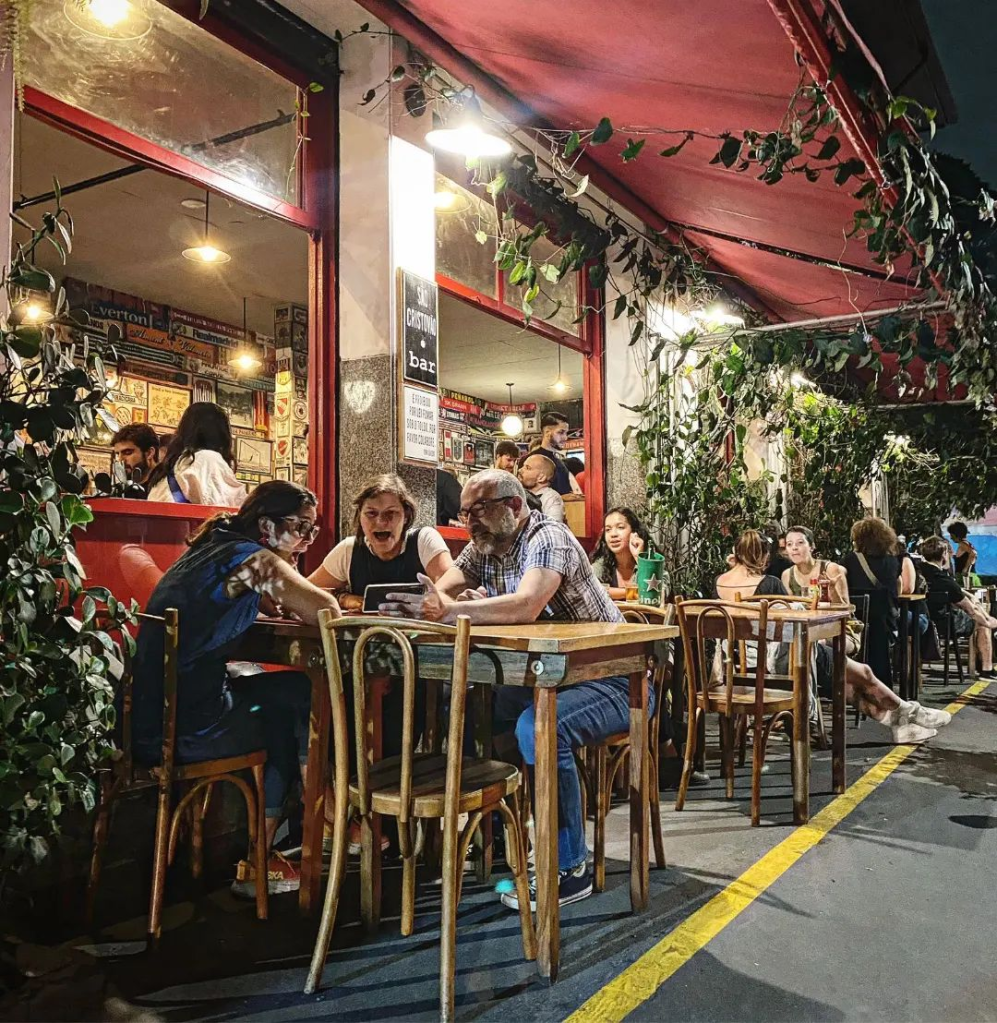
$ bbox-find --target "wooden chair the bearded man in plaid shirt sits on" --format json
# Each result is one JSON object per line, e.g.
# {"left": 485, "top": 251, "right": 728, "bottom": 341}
{"left": 576, "top": 605, "right": 675, "bottom": 892}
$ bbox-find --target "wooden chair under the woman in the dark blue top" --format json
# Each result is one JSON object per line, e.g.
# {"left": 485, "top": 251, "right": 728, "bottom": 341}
{"left": 87, "top": 608, "right": 267, "bottom": 944}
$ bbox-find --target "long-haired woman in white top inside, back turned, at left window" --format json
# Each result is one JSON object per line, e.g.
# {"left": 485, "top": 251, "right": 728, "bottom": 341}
{"left": 147, "top": 401, "right": 245, "bottom": 507}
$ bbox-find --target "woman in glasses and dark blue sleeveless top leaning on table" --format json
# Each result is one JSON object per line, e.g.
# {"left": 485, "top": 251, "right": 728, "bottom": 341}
{"left": 132, "top": 480, "right": 338, "bottom": 895}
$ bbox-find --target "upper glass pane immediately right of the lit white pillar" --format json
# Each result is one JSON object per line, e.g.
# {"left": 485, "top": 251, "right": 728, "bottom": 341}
{"left": 437, "top": 174, "right": 498, "bottom": 299}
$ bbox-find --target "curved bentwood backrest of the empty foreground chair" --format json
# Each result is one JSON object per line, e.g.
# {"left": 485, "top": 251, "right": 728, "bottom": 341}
{"left": 319, "top": 609, "right": 470, "bottom": 824}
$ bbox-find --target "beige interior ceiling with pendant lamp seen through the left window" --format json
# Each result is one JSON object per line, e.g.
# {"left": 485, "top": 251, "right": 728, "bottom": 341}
{"left": 14, "top": 114, "right": 308, "bottom": 336}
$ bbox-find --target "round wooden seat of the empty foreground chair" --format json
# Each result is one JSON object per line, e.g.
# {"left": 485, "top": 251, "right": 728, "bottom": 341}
{"left": 350, "top": 753, "right": 519, "bottom": 817}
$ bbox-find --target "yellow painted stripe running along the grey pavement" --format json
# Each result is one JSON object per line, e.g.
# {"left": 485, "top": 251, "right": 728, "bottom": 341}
{"left": 567, "top": 681, "right": 990, "bottom": 1023}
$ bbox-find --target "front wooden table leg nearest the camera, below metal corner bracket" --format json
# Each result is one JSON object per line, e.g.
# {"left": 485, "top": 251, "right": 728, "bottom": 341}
{"left": 534, "top": 686, "right": 560, "bottom": 983}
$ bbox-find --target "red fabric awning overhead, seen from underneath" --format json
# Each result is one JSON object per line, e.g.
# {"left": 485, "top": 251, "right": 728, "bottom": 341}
{"left": 357, "top": 0, "right": 928, "bottom": 319}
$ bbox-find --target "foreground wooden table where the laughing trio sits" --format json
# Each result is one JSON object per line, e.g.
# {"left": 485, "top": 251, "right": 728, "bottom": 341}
{"left": 231, "top": 621, "right": 679, "bottom": 982}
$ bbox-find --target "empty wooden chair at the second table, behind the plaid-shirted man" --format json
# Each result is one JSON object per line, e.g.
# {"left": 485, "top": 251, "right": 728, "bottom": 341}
{"left": 675, "top": 598, "right": 798, "bottom": 825}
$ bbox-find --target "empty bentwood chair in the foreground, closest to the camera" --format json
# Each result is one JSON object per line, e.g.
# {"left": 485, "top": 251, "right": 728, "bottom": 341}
{"left": 305, "top": 611, "right": 537, "bottom": 1020}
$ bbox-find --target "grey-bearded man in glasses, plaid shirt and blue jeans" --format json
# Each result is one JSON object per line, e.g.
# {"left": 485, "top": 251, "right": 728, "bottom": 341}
{"left": 380, "top": 470, "right": 650, "bottom": 909}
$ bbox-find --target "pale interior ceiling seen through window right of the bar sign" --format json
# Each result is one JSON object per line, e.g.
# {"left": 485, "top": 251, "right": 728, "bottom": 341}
{"left": 440, "top": 293, "right": 583, "bottom": 402}
